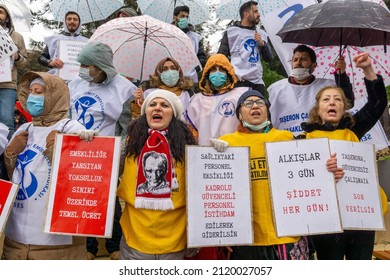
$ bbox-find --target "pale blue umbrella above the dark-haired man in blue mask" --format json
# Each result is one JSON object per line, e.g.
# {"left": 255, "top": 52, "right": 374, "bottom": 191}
{"left": 137, "top": 0, "right": 209, "bottom": 25}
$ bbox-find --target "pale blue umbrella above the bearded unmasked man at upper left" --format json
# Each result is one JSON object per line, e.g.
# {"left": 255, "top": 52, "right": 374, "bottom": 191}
{"left": 50, "top": 0, "right": 123, "bottom": 23}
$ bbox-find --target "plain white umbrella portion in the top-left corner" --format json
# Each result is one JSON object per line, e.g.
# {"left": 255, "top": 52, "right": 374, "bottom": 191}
{"left": 0, "top": 0, "right": 31, "bottom": 32}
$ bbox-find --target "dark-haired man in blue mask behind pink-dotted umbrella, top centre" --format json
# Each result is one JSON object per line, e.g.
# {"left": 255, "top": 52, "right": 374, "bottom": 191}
{"left": 172, "top": 6, "right": 207, "bottom": 83}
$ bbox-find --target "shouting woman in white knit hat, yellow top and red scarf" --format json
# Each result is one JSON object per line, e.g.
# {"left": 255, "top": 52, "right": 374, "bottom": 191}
{"left": 118, "top": 89, "right": 196, "bottom": 260}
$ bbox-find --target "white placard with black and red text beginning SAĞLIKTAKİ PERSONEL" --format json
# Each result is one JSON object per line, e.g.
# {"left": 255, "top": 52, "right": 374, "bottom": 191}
{"left": 186, "top": 146, "right": 253, "bottom": 247}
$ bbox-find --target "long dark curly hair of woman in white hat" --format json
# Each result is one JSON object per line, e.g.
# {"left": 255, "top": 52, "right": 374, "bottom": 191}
{"left": 125, "top": 114, "right": 197, "bottom": 164}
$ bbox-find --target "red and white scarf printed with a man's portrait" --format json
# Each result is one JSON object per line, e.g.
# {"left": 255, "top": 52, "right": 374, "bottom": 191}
{"left": 135, "top": 129, "right": 178, "bottom": 210}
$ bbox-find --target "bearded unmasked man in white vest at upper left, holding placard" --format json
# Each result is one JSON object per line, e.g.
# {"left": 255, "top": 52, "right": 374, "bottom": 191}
{"left": 38, "top": 11, "right": 88, "bottom": 78}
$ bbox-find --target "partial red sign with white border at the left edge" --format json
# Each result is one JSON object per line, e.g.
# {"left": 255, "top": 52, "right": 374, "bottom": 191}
{"left": 0, "top": 179, "right": 19, "bottom": 235}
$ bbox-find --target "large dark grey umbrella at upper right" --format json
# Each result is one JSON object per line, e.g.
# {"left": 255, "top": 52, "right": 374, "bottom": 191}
{"left": 277, "top": 0, "right": 390, "bottom": 53}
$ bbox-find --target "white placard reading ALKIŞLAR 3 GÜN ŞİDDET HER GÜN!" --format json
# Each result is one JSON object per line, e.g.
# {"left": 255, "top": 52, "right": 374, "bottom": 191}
{"left": 265, "top": 138, "right": 342, "bottom": 237}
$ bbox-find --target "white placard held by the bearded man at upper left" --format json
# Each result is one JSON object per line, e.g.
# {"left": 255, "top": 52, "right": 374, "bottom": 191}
{"left": 58, "top": 40, "right": 87, "bottom": 81}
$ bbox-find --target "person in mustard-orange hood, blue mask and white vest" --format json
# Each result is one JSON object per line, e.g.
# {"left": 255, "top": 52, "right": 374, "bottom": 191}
{"left": 187, "top": 54, "right": 249, "bottom": 146}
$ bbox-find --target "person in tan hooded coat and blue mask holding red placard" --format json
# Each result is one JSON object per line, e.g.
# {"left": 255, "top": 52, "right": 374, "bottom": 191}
{"left": 2, "top": 72, "right": 93, "bottom": 260}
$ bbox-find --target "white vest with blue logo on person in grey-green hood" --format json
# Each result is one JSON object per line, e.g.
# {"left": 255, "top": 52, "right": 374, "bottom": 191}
{"left": 69, "top": 74, "right": 137, "bottom": 136}
